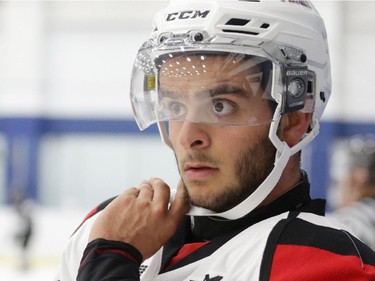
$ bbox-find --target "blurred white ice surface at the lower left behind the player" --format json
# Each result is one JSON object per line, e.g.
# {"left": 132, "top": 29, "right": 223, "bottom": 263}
{"left": 0, "top": 206, "right": 84, "bottom": 281}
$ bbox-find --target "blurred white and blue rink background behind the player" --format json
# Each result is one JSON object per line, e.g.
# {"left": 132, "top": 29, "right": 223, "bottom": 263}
{"left": 0, "top": 0, "right": 375, "bottom": 281}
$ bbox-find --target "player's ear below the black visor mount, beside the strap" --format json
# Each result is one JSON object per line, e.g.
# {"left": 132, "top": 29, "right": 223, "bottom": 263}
{"left": 279, "top": 111, "right": 312, "bottom": 147}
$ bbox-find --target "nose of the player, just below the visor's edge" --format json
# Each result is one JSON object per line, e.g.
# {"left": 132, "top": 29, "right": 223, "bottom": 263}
{"left": 178, "top": 121, "right": 210, "bottom": 150}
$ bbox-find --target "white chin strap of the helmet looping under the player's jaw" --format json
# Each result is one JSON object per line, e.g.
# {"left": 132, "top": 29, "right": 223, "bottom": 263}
{"left": 158, "top": 107, "right": 319, "bottom": 220}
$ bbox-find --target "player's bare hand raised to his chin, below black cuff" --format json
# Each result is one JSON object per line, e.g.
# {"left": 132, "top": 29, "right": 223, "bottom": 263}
{"left": 89, "top": 178, "right": 190, "bottom": 259}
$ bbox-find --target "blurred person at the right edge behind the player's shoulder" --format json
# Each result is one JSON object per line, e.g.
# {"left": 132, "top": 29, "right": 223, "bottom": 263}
{"left": 328, "top": 135, "right": 375, "bottom": 250}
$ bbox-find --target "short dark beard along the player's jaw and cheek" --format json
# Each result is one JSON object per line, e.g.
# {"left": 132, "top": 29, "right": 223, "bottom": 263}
{"left": 176, "top": 132, "right": 276, "bottom": 213}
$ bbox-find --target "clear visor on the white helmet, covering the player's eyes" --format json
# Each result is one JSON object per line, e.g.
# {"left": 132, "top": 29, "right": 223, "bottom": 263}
{"left": 131, "top": 43, "right": 277, "bottom": 130}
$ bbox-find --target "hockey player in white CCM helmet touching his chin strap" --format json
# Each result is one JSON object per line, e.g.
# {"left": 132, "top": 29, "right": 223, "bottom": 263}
{"left": 59, "top": 0, "right": 375, "bottom": 281}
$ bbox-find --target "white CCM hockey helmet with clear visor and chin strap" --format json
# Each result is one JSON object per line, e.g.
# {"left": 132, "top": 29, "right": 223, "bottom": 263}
{"left": 130, "top": 0, "right": 331, "bottom": 219}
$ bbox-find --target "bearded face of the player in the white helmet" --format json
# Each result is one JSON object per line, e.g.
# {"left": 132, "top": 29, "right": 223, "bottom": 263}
{"left": 159, "top": 53, "right": 275, "bottom": 212}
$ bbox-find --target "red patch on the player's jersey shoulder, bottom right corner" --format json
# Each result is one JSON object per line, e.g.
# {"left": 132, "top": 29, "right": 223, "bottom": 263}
{"left": 270, "top": 245, "right": 375, "bottom": 281}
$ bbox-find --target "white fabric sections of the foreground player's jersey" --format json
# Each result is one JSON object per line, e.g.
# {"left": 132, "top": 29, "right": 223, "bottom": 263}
{"left": 57, "top": 209, "right": 356, "bottom": 281}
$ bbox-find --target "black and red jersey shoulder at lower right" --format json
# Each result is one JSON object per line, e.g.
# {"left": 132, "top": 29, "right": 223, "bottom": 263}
{"left": 262, "top": 214, "right": 375, "bottom": 281}
